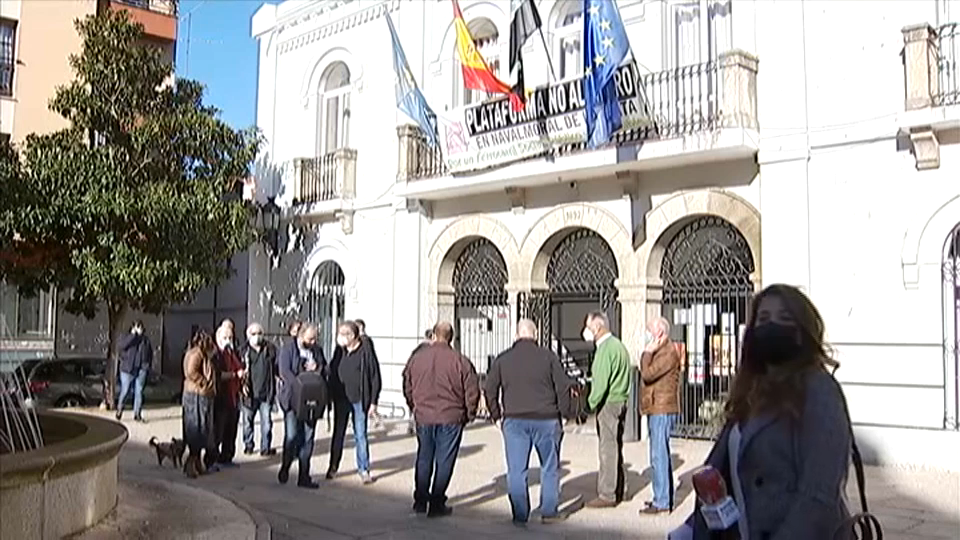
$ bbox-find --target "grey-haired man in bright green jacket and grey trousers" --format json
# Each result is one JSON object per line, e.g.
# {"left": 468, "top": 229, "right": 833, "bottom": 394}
{"left": 583, "top": 311, "right": 630, "bottom": 508}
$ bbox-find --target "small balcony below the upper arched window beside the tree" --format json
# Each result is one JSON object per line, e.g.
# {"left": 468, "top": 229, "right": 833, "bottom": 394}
{"left": 287, "top": 148, "right": 357, "bottom": 234}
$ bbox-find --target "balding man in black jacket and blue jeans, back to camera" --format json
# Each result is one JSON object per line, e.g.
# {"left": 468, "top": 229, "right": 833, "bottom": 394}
{"left": 485, "top": 319, "right": 573, "bottom": 525}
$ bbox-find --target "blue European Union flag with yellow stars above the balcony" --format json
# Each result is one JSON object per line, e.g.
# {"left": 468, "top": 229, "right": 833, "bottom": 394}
{"left": 583, "top": 0, "right": 630, "bottom": 148}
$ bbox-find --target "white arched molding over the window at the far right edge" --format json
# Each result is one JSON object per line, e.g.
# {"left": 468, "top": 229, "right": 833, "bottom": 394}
{"left": 900, "top": 194, "right": 960, "bottom": 289}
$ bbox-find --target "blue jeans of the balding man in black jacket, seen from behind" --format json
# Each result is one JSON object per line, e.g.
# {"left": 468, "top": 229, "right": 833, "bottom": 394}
{"left": 503, "top": 418, "right": 563, "bottom": 523}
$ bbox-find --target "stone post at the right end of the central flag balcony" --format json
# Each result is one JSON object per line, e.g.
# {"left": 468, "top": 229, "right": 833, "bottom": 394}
{"left": 720, "top": 49, "right": 759, "bottom": 129}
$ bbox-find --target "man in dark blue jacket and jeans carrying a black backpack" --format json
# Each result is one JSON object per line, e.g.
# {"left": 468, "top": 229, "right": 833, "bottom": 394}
{"left": 277, "top": 324, "right": 327, "bottom": 489}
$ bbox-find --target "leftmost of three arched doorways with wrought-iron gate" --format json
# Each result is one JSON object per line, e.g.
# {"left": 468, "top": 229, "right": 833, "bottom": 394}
{"left": 453, "top": 238, "right": 513, "bottom": 374}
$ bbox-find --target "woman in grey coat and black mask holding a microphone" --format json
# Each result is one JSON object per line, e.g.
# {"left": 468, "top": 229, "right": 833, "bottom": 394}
{"left": 670, "top": 285, "right": 852, "bottom": 540}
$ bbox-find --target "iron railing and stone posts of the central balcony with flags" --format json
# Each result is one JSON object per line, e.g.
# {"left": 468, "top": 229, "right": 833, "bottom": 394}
{"left": 398, "top": 51, "right": 757, "bottom": 180}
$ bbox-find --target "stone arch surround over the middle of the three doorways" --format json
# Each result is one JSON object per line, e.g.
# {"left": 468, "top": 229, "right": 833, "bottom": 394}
{"left": 517, "top": 203, "right": 636, "bottom": 289}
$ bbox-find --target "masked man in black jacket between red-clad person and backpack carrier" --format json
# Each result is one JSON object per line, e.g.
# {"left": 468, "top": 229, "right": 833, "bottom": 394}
{"left": 240, "top": 323, "right": 278, "bottom": 456}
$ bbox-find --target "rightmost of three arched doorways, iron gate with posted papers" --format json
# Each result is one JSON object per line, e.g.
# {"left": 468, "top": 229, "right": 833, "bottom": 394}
{"left": 660, "top": 216, "right": 754, "bottom": 438}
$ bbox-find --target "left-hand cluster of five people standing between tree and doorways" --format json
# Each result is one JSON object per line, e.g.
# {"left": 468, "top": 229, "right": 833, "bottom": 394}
{"left": 174, "top": 319, "right": 382, "bottom": 489}
